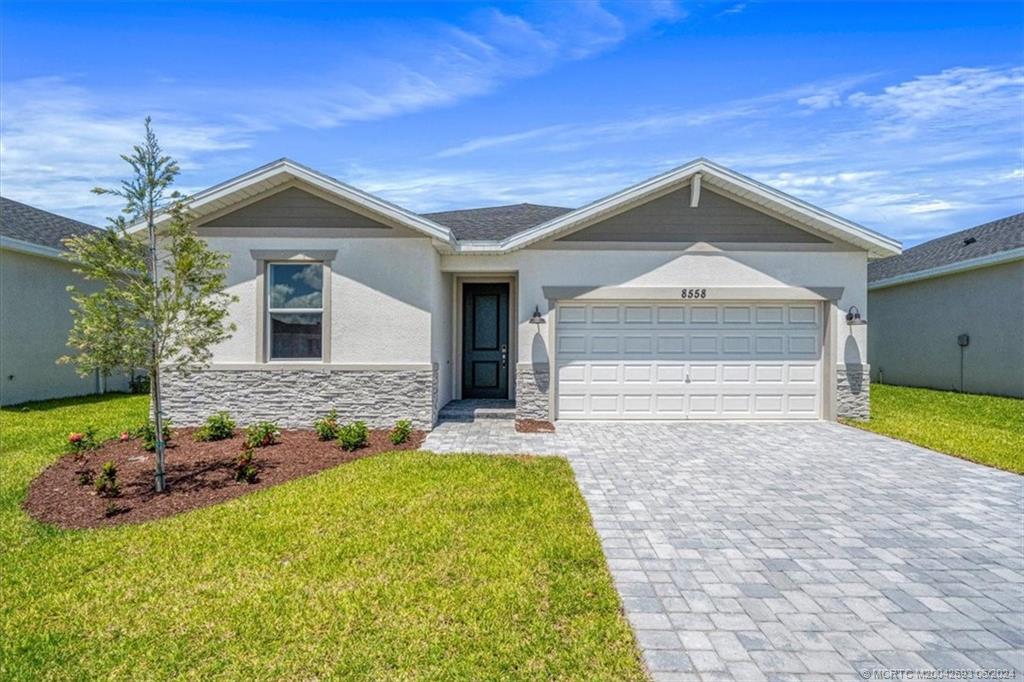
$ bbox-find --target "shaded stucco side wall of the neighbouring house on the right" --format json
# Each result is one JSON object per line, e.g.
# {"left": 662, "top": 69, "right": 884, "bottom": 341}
{"left": 868, "top": 261, "right": 1024, "bottom": 397}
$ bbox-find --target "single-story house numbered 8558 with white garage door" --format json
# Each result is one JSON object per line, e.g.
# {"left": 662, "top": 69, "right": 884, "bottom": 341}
{"left": 133, "top": 159, "right": 900, "bottom": 428}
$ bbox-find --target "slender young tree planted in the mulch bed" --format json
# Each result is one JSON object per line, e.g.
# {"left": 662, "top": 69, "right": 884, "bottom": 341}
{"left": 60, "top": 118, "right": 237, "bottom": 493}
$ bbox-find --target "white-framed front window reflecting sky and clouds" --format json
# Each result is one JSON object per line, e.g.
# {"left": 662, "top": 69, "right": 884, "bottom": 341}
{"left": 266, "top": 262, "right": 324, "bottom": 359}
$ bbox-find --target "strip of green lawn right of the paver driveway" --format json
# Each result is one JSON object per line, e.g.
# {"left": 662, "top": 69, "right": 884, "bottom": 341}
{"left": 847, "top": 384, "right": 1024, "bottom": 473}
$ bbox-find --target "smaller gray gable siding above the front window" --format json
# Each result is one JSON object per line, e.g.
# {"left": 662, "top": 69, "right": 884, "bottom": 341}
{"left": 203, "top": 187, "right": 390, "bottom": 229}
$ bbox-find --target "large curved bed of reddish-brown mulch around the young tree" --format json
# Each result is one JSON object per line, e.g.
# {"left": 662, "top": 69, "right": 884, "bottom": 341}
{"left": 25, "top": 428, "right": 426, "bottom": 528}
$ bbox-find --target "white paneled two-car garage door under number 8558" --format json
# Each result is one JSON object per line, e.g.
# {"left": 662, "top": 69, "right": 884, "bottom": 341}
{"left": 556, "top": 302, "right": 821, "bottom": 420}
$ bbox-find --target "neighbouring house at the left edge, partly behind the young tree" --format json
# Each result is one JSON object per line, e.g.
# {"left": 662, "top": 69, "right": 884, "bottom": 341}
{"left": 0, "top": 198, "right": 128, "bottom": 404}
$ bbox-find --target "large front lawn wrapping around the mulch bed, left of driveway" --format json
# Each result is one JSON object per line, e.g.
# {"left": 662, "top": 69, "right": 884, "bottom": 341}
{"left": 0, "top": 396, "right": 645, "bottom": 680}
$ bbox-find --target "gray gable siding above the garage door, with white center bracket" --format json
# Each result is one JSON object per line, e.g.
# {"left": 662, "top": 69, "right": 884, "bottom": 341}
{"left": 558, "top": 186, "right": 826, "bottom": 244}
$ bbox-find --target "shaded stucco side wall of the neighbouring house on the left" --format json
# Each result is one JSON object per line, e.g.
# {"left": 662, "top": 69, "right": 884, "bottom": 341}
{"left": 0, "top": 249, "right": 127, "bottom": 404}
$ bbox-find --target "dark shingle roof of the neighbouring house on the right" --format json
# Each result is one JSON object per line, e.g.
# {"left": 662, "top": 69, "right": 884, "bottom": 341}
{"left": 867, "top": 213, "right": 1024, "bottom": 282}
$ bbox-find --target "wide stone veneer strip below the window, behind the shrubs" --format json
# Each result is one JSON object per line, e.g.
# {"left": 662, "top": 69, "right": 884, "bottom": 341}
{"left": 163, "top": 368, "right": 437, "bottom": 429}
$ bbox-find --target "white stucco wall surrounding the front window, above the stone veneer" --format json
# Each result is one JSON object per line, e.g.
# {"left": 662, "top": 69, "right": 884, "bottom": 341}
{"left": 200, "top": 236, "right": 451, "bottom": 366}
